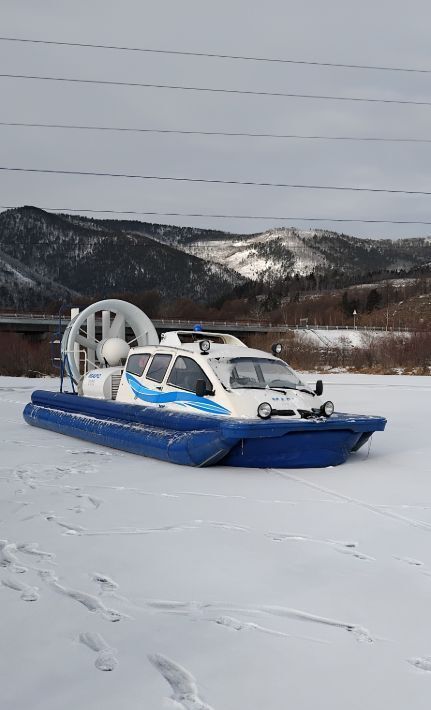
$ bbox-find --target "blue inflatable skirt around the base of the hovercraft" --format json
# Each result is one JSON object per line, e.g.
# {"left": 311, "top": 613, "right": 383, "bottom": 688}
{"left": 23, "top": 390, "right": 386, "bottom": 468}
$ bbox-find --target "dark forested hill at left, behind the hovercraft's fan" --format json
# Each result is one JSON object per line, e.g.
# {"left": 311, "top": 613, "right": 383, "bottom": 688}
{"left": 0, "top": 207, "right": 244, "bottom": 306}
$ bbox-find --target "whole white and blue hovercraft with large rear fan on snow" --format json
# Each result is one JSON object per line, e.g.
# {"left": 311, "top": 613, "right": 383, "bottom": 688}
{"left": 24, "top": 299, "right": 386, "bottom": 468}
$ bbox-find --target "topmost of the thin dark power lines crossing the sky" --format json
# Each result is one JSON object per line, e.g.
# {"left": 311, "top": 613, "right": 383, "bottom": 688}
{"left": 0, "top": 37, "right": 431, "bottom": 74}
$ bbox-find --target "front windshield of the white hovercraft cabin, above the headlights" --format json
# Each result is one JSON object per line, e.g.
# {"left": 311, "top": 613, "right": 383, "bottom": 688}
{"left": 209, "top": 357, "right": 305, "bottom": 389}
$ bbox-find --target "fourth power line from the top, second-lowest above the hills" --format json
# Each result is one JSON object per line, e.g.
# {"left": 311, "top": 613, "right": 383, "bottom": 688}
{"left": 0, "top": 166, "right": 431, "bottom": 196}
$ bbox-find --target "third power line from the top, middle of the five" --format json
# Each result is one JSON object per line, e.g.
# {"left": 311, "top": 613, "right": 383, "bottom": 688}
{"left": 0, "top": 121, "right": 431, "bottom": 143}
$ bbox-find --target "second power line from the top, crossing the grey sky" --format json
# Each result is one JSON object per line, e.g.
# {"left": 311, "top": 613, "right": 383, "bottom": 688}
{"left": 0, "top": 74, "right": 431, "bottom": 106}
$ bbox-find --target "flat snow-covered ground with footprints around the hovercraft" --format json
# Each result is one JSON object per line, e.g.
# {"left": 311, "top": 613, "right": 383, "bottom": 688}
{"left": 0, "top": 374, "right": 431, "bottom": 710}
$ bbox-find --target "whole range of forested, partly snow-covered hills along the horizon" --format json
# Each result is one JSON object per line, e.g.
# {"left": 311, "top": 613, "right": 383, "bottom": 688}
{"left": 0, "top": 207, "right": 431, "bottom": 307}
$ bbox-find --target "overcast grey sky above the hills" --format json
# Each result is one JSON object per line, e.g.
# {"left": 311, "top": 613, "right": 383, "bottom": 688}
{"left": 0, "top": 0, "right": 431, "bottom": 237}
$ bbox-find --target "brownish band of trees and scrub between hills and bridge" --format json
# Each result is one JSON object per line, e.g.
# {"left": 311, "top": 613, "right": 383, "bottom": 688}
{"left": 62, "top": 276, "right": 431, "bottom": 330}
